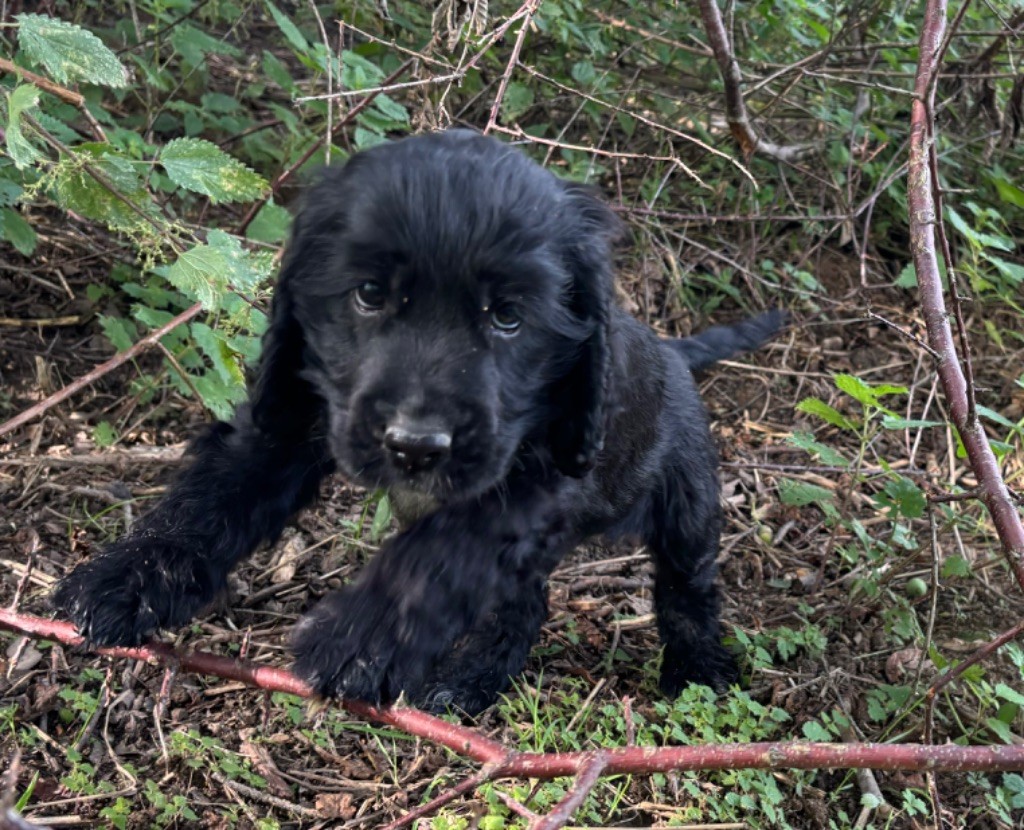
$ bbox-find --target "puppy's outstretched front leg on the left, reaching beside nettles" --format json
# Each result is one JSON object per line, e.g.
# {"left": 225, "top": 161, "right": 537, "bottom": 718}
{"left": 53, "top": 411, "right": 328, "bottom": 646}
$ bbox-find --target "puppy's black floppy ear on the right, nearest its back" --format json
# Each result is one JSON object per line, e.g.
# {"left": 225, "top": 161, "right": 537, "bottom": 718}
{"left": 551, "top": 183, "right": 624, "bottom": 478}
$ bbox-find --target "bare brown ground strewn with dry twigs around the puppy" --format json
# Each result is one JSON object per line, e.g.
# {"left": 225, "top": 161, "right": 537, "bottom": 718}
{"left": 0, "top": 215, "right": 1024, "bottom": 828}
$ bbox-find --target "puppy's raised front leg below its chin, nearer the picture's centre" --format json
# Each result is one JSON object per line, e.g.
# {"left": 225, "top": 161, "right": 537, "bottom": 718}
{"left": 292, "top": 485, "right": 575, "bottom": 703}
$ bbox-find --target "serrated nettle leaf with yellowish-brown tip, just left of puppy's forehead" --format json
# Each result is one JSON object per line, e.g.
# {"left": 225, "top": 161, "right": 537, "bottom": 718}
{"left": 160, "top": 138, "right": 267, "bottom": 204}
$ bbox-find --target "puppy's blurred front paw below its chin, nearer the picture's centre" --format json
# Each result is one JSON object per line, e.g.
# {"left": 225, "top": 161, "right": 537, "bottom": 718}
{"left": 292, "top": 585, "right": 450, "bottom": 704}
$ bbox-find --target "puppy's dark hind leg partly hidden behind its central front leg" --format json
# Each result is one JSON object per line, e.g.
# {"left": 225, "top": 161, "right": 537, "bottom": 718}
{"left": 414, "top": 574, "right": 548, "bottom": 714}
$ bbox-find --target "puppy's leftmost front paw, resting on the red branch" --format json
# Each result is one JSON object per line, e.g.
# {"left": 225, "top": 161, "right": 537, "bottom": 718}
{"left": 53, "top": 536, "right": 224, "bottom": 646}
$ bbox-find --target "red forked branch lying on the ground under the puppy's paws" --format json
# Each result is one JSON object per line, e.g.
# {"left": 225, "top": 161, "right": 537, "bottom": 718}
{"left": 0, "top": 609, "right": 1024, "bottom": 830}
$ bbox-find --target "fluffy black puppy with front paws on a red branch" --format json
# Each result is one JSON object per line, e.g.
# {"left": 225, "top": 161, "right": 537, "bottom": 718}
{"left": 54, "top": 131, "right": 782, "bottom": 712}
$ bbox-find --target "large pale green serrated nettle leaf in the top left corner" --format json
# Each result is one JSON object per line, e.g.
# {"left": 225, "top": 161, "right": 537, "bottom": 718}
{"left": 14, "top": 14, "right": 128, "bottom": 87}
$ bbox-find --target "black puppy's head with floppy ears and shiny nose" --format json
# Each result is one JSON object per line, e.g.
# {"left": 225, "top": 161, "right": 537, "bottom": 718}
{"left": 255, "top": 131, "right": 617, "bottom": 501}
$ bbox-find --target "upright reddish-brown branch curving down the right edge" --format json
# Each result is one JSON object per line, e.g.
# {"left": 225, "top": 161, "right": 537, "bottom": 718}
{"left": 907, "top": 0, "right": 1024, "bottom": 588}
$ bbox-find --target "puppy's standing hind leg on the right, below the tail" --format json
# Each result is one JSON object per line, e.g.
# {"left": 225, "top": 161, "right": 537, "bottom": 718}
{"left": 645, "top": 453, "right": 739, "bottom": 696}
